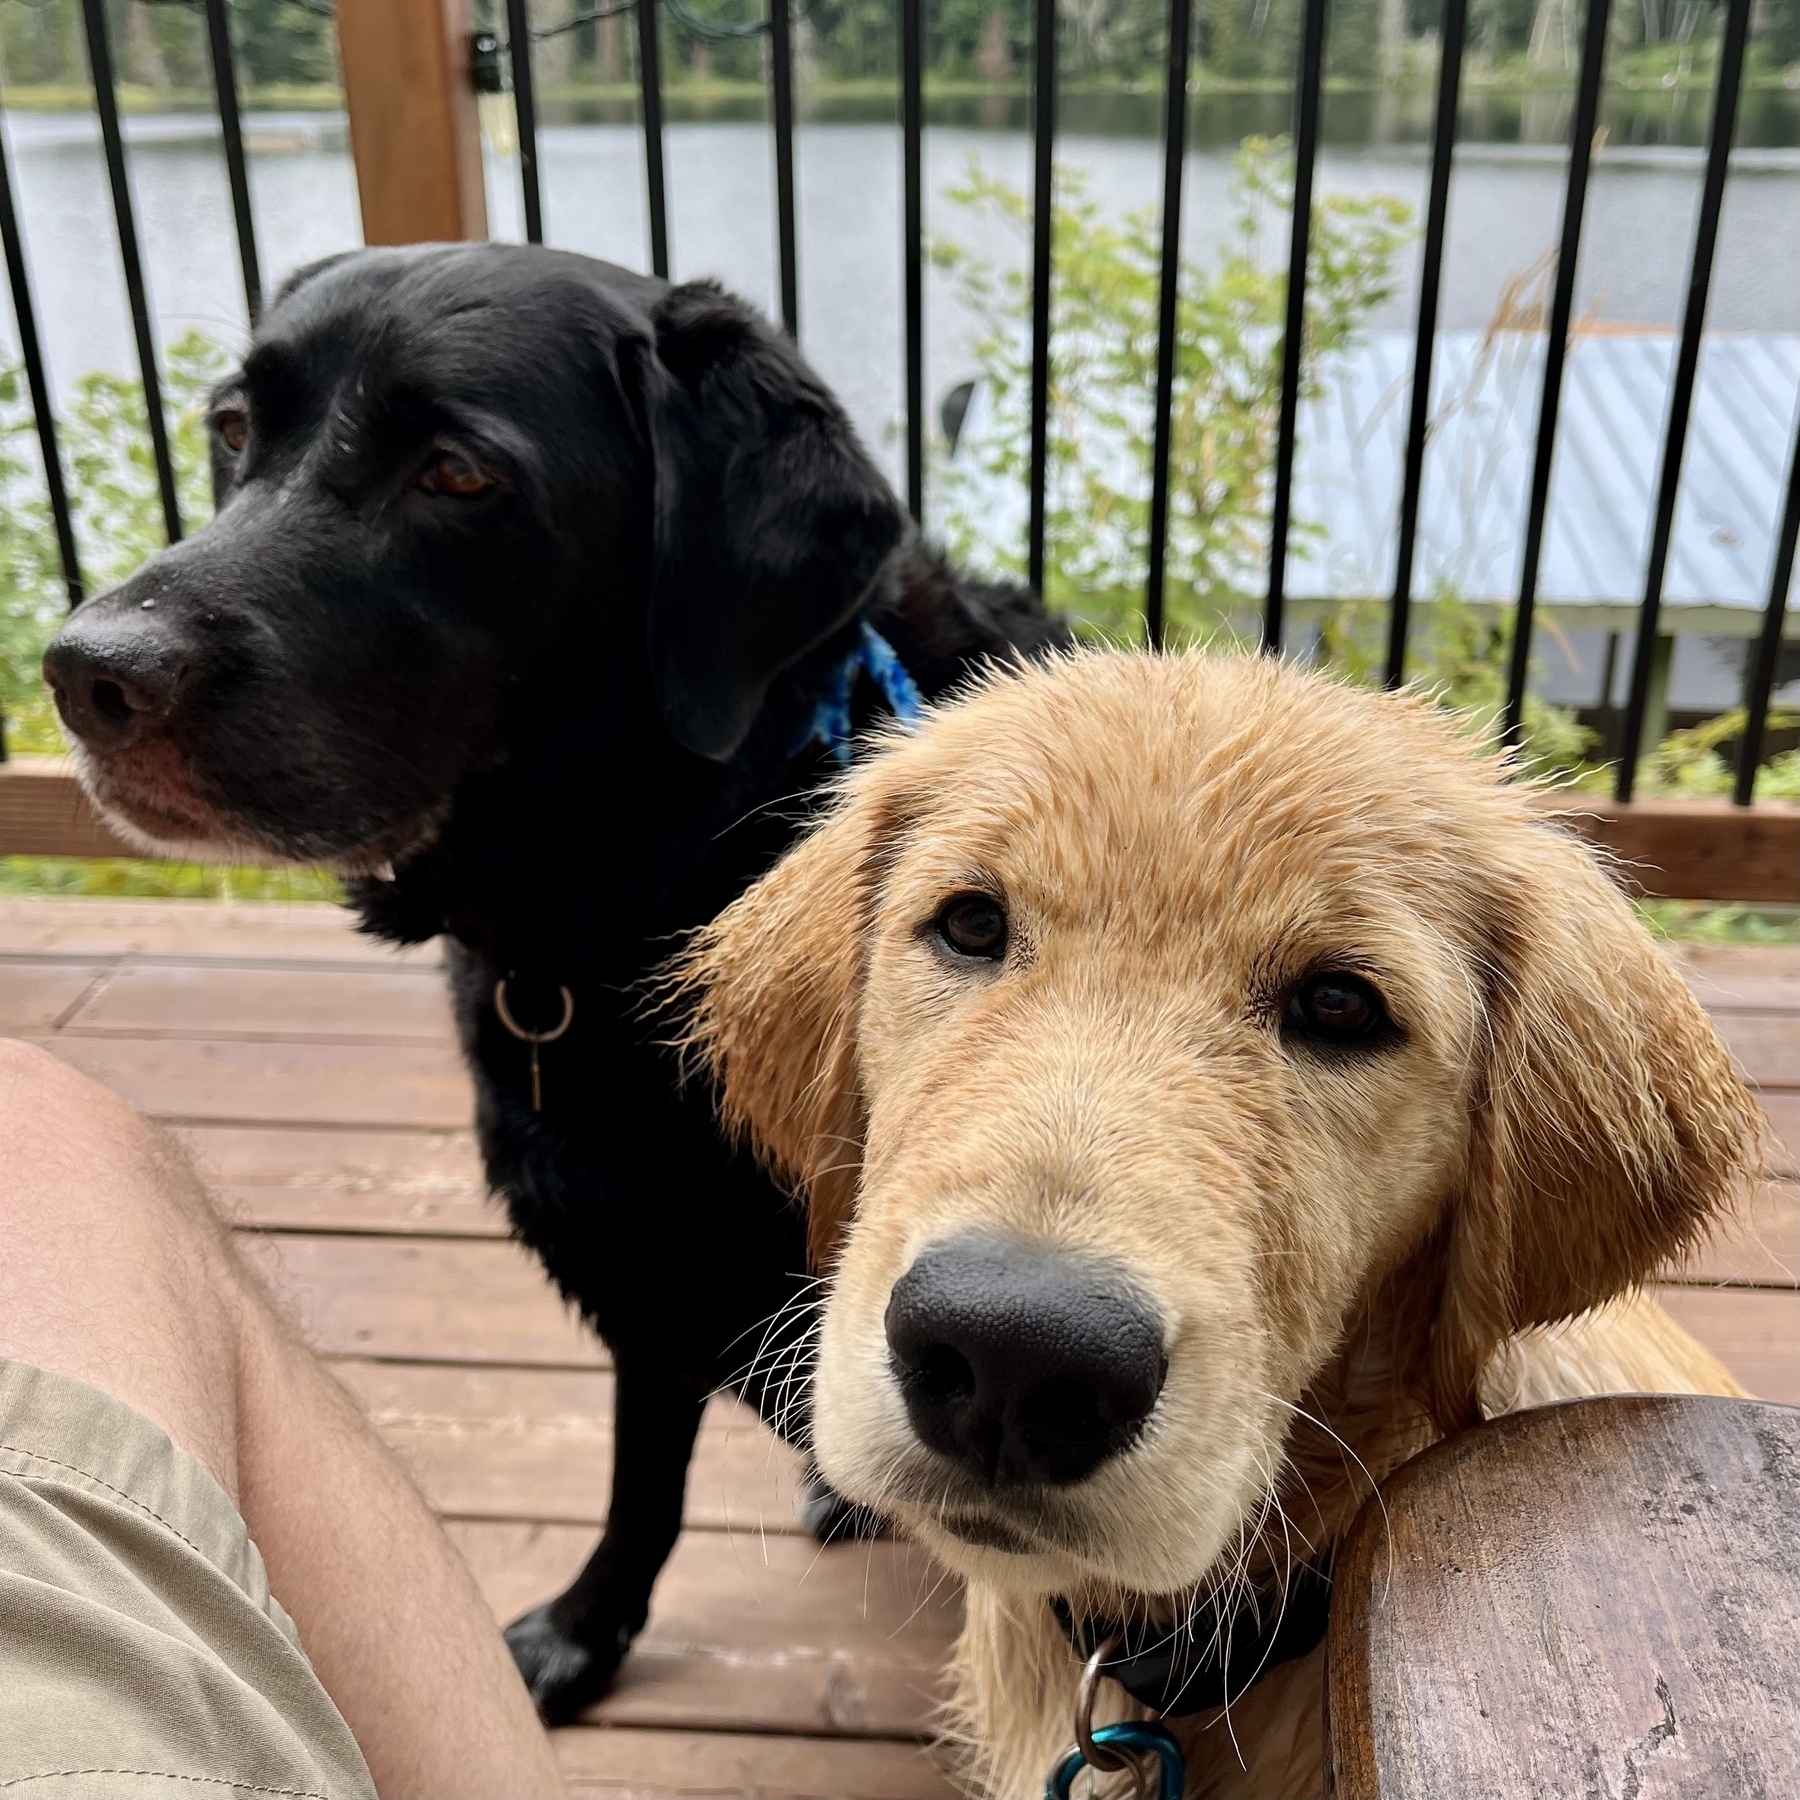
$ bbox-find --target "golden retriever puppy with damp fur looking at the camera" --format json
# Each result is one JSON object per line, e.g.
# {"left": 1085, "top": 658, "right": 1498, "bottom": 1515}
{"left": 682, "top": 653, "right": 1760, "bottom": 1800}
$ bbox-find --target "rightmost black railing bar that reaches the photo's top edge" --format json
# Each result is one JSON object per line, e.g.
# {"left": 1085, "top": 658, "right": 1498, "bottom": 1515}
{"left": 1613, "top": 0, "right": 1750, "bottom": 803}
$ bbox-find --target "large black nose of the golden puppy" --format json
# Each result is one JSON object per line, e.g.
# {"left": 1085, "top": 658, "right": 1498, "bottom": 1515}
{"left": 887, "top": 1233, "right": 1168, "bottom": 1487}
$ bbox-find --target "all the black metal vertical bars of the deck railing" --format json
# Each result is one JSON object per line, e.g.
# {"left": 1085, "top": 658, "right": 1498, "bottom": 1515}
{"left": 0, "top": 0, "right": 1800, "bottom": 805}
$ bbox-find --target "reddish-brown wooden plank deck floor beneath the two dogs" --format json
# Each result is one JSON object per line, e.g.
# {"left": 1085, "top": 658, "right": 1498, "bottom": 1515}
{"left": 0, "top": 900, "right": 1800, "bottom": 1800}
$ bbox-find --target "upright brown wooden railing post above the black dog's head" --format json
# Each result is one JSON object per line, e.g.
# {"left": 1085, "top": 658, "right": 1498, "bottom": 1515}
{"left": 337, "top": 0, "right": 488, "bottom": 243}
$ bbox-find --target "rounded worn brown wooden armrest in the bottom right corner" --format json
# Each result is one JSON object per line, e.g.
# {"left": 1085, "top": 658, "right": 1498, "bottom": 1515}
{"left": 1325, "top": 1395, "right": 1800, "bottom": 1800}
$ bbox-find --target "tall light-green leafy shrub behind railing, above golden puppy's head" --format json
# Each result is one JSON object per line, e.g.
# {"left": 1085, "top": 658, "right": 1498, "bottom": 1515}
{"left": 932, "top": 139, "right": 1411, "bottom": 643}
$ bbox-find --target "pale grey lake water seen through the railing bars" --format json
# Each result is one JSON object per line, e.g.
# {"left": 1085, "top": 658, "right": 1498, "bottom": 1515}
{"left": 5, "top": 95, "right": 1800, "bottom": 511}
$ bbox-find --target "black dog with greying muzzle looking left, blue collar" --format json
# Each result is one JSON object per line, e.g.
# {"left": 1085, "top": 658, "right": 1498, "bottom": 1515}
{"left": 45, "top": 247, "right": 1062, "bottom": 1721}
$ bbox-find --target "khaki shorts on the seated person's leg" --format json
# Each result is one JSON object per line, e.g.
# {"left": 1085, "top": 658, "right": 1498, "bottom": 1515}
{"left": 0, "top": 1359, "right": 374, "bottom": 1800}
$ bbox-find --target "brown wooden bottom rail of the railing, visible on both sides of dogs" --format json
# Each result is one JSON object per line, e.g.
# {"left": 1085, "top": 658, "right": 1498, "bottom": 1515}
{"left": 0, "top": 756, "right": 1800, "bottom": 904}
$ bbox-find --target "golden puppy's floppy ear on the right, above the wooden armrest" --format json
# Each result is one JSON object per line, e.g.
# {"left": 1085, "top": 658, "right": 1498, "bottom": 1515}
{"left": 1427, "top": 824, "right": 1764, "bottom": 1431}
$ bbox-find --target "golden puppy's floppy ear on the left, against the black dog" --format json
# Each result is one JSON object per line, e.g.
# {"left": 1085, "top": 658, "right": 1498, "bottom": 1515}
{"left": 675, "top": 772, "right": 898, "bottom": 1269}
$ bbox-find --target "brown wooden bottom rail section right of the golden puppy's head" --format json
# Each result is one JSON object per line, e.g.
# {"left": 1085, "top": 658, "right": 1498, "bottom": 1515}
{"left": 1543, "top": 794, "right": 1800, "bottom": 904}
